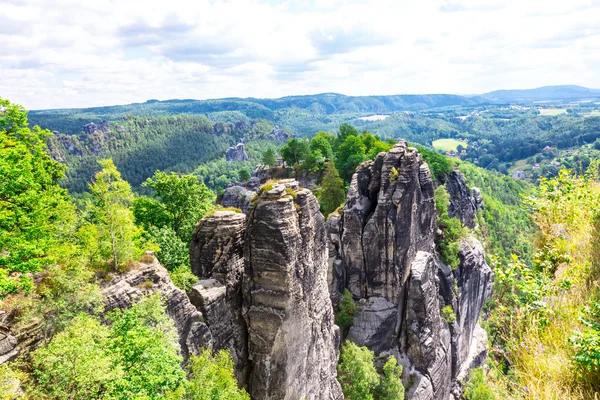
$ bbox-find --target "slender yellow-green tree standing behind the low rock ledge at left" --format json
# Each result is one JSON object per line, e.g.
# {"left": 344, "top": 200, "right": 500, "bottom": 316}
{"left": 89, "top": 159, "right": 140, "bottom": 271}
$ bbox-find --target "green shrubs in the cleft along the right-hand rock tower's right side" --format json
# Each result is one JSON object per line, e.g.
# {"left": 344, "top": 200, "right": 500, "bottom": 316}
{"left": 435, "top": 185, "right": 465, "bottom": 269}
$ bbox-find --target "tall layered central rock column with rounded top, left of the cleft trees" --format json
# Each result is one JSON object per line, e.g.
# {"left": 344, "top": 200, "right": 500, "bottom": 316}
{"left": 244, "top": 181, "right": 342, "bottom": 400}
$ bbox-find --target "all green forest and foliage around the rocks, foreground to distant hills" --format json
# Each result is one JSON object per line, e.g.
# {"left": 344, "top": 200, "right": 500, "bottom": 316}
{"left": 0, "top": 93, "right": 600, "bottom": 400}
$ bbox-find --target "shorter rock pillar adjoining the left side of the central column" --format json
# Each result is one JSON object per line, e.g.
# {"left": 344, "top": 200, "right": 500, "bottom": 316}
{"left": 190, "top": 211, "right": 248, "bottom": 384}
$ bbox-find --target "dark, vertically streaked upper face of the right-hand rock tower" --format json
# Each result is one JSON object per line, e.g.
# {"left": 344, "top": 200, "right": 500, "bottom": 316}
{"left": 340, "top": 142, "right": 435, "bottom": 303}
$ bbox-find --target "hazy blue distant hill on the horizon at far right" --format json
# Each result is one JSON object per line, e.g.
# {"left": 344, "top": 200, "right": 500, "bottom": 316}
{"left": 479, "top": 85, "right": 600, "bottom": 103}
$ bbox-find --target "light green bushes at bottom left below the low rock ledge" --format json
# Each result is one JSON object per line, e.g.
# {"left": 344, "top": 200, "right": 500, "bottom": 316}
{"left": 31, "top": 294, "right": 185, "bottom": 400}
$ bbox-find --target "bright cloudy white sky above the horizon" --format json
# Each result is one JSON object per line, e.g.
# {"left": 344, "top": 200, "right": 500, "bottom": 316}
{"left": 0, "top": 0, "right": 600, "bottom": 109}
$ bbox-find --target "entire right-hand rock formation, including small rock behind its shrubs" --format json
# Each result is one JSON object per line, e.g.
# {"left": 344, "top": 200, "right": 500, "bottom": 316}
{"left": 327, "top": 141, "right": 493, "bottom": 400}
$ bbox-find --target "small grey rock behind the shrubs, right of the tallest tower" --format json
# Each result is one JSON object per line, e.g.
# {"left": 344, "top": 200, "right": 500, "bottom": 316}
{"left": 446, "top": 169, "right": 483, "bottom": 229}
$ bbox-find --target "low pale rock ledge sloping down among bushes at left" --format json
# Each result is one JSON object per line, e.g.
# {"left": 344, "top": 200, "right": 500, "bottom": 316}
{"left": 101, "top": 253, "right": 213, "bottom": 359}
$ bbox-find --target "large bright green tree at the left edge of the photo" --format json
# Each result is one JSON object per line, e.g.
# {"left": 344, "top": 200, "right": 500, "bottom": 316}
{"left": 0, "top": 98, "right": 74, "bottom": 298}
